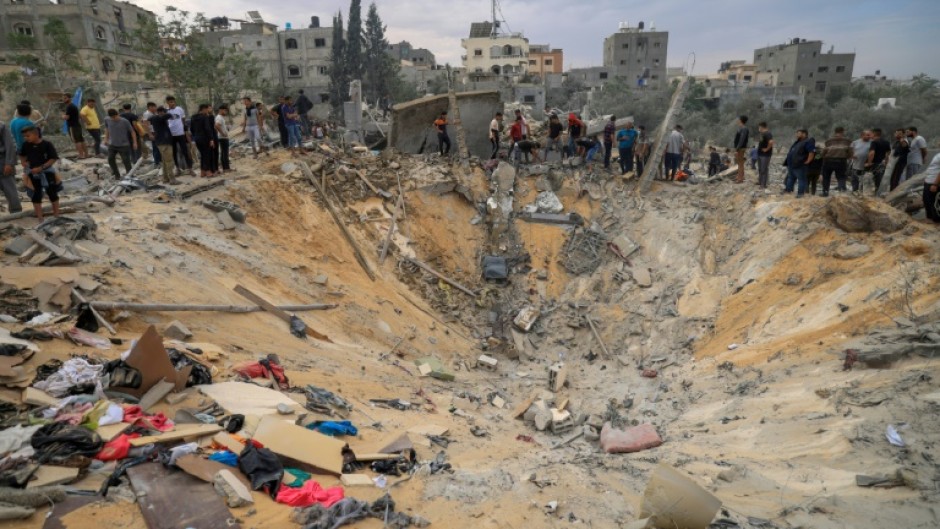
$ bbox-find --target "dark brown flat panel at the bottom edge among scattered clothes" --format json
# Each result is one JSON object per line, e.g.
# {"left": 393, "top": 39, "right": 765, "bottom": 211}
{"left": 127, "top": 463, "right": 241, "bottom": 529}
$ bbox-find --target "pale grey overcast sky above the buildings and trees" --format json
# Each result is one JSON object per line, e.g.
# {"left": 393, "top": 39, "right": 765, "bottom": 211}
{"left": 135, "top": 0, "right": 940, "bottom": 78}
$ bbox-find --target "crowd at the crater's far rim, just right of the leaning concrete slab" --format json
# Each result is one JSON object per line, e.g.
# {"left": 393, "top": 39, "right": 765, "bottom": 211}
{"left": 482, "top": 108, "right": 652, "bottom": 175}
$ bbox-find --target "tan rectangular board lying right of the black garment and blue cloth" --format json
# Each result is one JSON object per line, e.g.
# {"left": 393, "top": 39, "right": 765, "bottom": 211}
{"left": 254, "top": 415, "right": 346, "bottom": 476}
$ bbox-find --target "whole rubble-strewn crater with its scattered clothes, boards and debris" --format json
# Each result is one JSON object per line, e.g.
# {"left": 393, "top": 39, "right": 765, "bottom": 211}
{"left": 0, "top": 97, "right": 940, "bottom": 529}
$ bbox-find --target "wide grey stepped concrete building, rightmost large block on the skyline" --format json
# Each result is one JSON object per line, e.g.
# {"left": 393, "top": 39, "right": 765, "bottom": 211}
{"left": 754, "top": 38, "right": 855, "bottom": 93}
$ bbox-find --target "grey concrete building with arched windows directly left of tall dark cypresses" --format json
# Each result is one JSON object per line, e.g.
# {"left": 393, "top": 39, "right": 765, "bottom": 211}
{"left": 218, "top": 12, "right": 333, "bottom": 105}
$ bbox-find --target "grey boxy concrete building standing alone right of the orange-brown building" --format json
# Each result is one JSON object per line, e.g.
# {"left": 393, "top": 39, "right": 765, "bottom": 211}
{"left": 604, "top": 21, "right": 669, "bottom": 88}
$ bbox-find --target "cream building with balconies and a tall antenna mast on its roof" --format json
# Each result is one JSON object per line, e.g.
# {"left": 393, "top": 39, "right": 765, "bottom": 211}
{"left": 460, "top": 22, "right": 529, "bottom": 81}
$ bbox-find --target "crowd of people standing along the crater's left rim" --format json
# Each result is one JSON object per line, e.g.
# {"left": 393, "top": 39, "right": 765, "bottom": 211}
{"left": 0, "top": 90, "right": 329, "bottom": 219}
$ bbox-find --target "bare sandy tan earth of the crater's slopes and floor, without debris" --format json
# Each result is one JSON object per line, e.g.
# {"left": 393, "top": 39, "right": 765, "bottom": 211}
{"left": 4, "top": 141, "right": 940, "bottom": 529}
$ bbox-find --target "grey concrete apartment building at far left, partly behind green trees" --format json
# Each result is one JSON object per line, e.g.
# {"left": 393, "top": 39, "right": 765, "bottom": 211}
{"left": 0, "top": 0, "right": 156, "bottom": 93}
